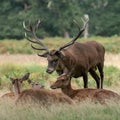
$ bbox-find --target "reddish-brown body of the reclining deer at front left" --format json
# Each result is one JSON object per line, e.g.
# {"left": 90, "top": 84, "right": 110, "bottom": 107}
{"left": 16, "top": 89, "right": 73, "bottom": 105}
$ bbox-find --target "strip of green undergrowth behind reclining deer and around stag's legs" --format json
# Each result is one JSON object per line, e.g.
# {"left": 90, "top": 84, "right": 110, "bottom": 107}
{"left": 0, "top": 63, "right": 120, "bottom": 89}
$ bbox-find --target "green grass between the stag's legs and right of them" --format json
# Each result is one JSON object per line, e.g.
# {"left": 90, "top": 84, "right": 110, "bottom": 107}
{"left": 70, "top": 66, "right": 120, "bottom": 87}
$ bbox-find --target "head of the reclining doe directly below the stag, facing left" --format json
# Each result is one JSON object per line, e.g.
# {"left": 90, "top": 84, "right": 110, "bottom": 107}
{"left": 50, "top": 74, "right": 70, "bottom": 89}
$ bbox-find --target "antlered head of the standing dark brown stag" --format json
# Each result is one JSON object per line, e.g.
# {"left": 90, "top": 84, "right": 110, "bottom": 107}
{"left": 23, "top": 17, "right": 88, "bottom": 74}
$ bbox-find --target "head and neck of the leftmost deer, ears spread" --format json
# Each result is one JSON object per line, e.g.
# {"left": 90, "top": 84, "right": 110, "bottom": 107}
{"left": 10, "top": 73, "right": 30, "bottom": 94}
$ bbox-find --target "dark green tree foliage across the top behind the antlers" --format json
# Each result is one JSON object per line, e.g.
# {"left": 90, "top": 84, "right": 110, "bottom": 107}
{"left": 0, "top": 0, "right": 120, "bottom": 39}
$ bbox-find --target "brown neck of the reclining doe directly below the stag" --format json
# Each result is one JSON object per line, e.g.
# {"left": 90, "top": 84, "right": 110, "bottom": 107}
{"left": 61, "top": 83, "right": 75, "bottom": 98}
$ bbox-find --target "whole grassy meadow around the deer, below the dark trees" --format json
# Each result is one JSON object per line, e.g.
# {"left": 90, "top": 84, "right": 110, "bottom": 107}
{"left": 0, "top": 36, "right": 120, "bottom": 120}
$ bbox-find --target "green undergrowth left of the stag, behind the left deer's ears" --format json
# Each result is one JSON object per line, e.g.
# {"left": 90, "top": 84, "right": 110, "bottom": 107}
{"left": 0, "top": 63, "right": 56, "bottom": 89}
